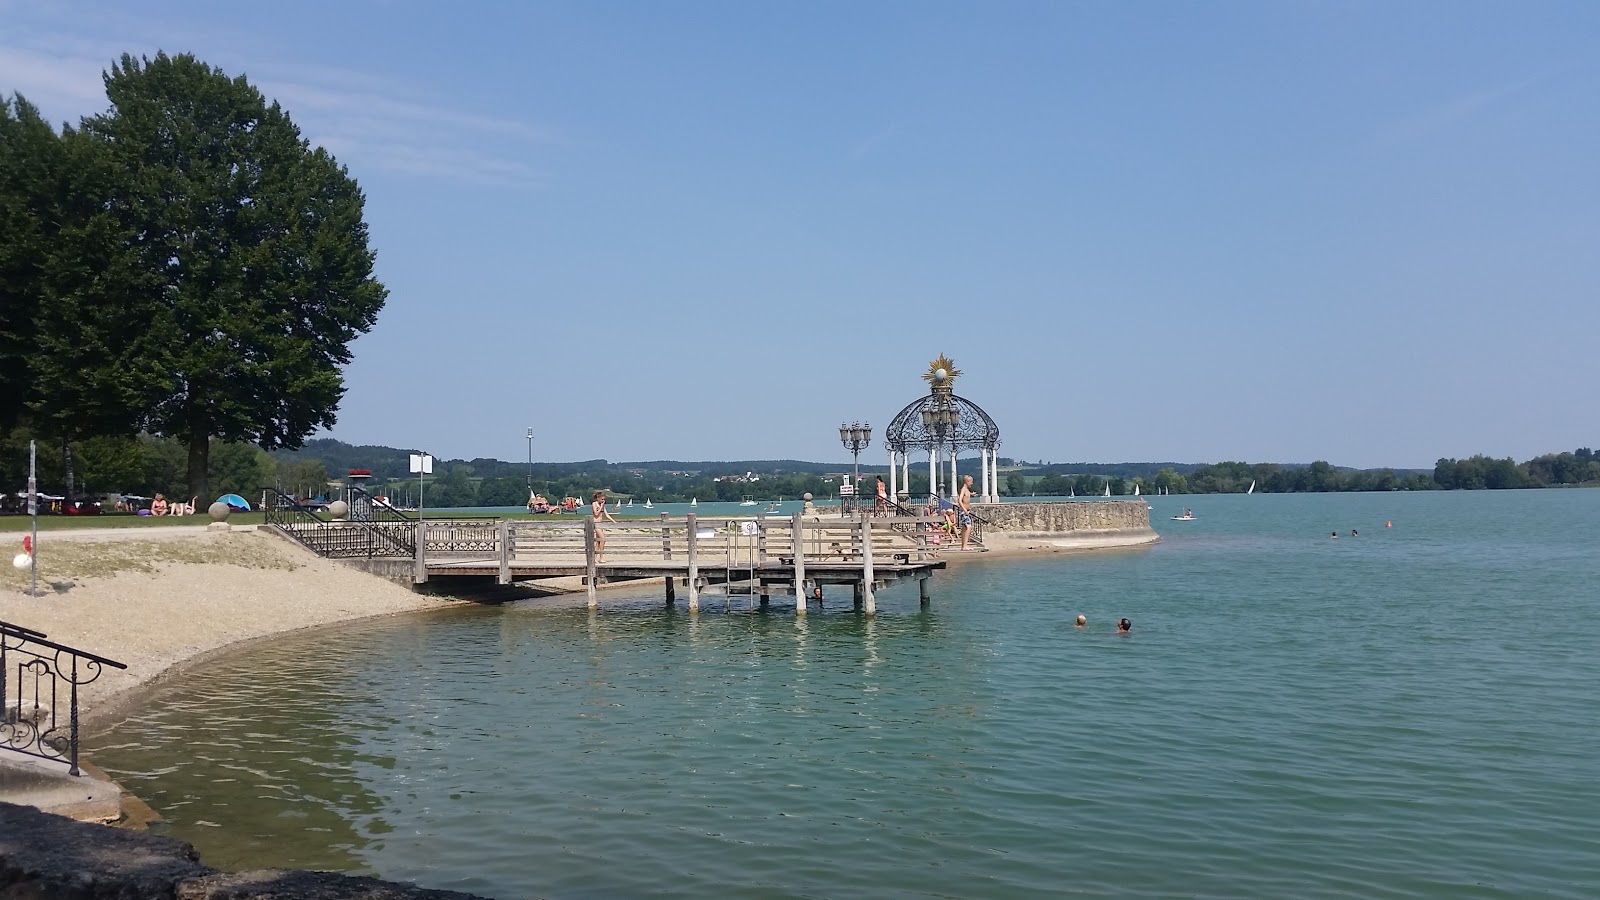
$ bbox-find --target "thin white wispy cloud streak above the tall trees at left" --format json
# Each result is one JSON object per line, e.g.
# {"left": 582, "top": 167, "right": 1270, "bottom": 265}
{"left": 0, "top": 9, "right": 558, "bottom": 187}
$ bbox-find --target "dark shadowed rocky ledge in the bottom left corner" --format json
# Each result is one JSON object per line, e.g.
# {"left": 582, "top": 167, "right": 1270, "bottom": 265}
{"left": 0, "top": 802, "right": 485, "bottom": 900}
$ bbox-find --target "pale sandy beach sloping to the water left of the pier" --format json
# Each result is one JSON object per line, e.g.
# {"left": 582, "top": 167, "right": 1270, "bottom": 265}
{"left": 0, "top": 527, "right": 459, "bottom": 719}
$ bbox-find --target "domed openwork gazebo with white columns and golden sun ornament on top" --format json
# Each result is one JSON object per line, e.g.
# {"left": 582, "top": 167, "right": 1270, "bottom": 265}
{"left": 883, "top": 354, "right": 1000, "bottom": 503}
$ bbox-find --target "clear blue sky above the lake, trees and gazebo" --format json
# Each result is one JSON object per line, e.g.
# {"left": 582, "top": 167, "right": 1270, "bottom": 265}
{"left": 0, "top": 0, "right": 1600, "bottom": 468}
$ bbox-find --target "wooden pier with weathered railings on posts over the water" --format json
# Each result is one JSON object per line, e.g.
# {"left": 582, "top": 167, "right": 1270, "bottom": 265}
{"left": 409, "top": 512, "right": 944, "bottom": 615}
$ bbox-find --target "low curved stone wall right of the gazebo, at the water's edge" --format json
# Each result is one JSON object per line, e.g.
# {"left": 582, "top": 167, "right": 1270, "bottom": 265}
{"left": 976, "top": 498, "right": 1162, "bottom": 549}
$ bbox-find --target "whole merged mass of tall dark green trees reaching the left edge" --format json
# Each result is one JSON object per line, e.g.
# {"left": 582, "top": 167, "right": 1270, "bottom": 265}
{"left": 0, "top": 53, "right": 387, "bottom": 495}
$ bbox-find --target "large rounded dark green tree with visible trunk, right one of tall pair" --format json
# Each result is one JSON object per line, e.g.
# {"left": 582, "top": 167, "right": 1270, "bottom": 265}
{"left": 82, "top": 53, "right": 387, "bottom": 500}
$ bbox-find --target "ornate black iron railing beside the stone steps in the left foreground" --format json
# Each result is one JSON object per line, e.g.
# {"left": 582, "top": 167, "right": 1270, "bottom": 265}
{"left": 0, "top": 621, "right": 128, "bottom": 775}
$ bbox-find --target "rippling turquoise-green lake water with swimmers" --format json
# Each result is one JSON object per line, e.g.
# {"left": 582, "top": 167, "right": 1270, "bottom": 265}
{"left": 93, "top": 490, "right": 1600, "bottom": 898}
